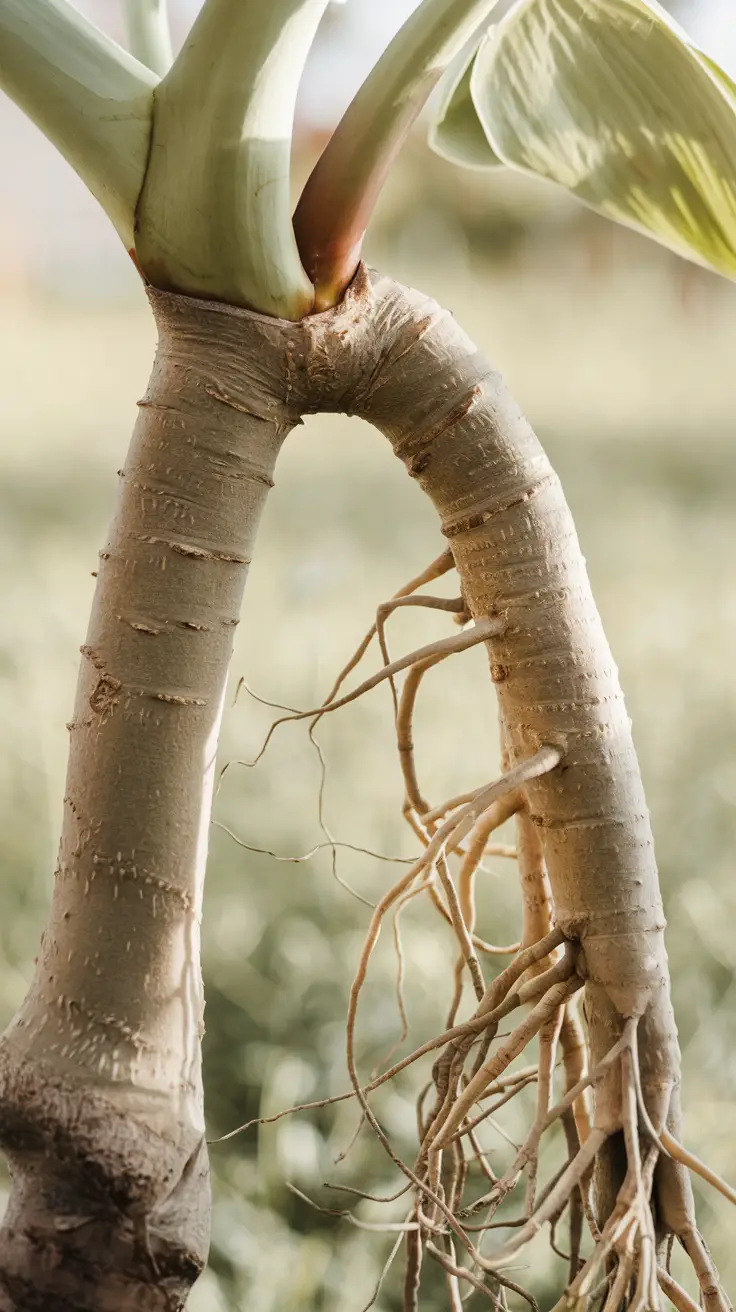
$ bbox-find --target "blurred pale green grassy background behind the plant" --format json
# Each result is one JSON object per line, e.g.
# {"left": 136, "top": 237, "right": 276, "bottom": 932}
{"left": 0, "top": 0, "right": 736, "bottom": 1312}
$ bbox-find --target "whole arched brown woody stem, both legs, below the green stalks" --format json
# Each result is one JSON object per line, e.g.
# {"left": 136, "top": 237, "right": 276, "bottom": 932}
{"left": 0, "top": 266, "right": 693, "bottom": 1312}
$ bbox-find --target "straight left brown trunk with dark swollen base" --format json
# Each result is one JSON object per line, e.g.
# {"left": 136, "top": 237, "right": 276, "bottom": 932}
{"left": 0, "top": 294, "right": 298, "bottom": 1312}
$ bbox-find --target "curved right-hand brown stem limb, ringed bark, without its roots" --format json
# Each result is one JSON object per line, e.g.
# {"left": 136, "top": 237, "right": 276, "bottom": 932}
{"left": 354, "top": 266, "right": 678, "bottom": 1120}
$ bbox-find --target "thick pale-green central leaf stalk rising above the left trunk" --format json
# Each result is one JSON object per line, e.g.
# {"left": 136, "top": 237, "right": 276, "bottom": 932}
{"left": 135, "top": 0, "right": 327, "bottom": 320}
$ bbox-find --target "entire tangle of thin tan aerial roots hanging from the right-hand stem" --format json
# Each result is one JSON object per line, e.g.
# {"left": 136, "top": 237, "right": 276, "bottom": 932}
{"left": 225, "top": 551, "right": 736, "bottom": 1312}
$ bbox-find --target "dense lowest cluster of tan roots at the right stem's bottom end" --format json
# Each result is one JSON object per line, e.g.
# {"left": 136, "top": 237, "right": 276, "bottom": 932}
{"left": 359, "top": 986, "right": 728, "bottom": 1312}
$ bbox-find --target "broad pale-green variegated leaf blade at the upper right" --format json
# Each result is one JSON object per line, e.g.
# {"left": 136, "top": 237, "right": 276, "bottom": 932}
{"left": 471, "top": 0, "right": 736, "bottom": 278}
